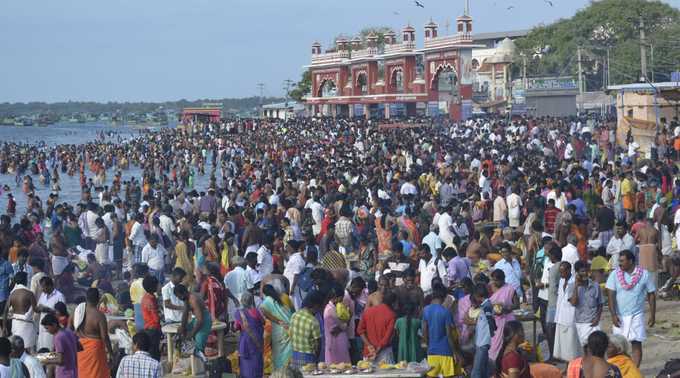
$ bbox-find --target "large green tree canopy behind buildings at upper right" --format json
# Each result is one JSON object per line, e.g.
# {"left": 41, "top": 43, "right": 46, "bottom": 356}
{"left": 515, "top": 0, "right": 680, "bottom": 90}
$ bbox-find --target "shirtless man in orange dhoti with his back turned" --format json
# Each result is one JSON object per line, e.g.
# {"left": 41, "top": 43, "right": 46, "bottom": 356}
{"left": 70, "top": 288, "right": 113, "bottom": 377}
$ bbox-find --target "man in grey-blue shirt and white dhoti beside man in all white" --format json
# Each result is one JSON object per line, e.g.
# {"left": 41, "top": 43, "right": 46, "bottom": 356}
{"left": 569, "top": 261, "right": 604, "bottom": 348}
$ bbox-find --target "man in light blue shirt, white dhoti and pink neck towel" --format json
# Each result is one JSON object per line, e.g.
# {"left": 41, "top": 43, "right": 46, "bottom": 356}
{"left": 607, "top": 250, "right": 656, "bottom": 367}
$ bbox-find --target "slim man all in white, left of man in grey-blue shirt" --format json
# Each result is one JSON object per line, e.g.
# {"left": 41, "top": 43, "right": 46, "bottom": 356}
{"left": 553, "top": 261, "right": 582, "bottom": 361}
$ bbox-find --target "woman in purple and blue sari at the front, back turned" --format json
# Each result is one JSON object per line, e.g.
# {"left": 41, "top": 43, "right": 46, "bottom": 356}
{"left": 234, "top": 292, "right": 264, "bottom": 378}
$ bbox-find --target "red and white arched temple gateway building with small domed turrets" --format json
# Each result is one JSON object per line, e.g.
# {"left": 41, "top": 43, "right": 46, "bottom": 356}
{"left": 305, "top": 5, "right": 480, "bottom": 119}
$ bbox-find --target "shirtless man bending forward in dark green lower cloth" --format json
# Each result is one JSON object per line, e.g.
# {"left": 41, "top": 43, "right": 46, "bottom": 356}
{"left": 173, "top": 284, "right": 212, "bottom": 362}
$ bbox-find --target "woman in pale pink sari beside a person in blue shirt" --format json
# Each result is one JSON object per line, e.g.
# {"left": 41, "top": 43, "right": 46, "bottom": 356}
{"left": 489, "top": 269, "right": 519, "bottom": 360}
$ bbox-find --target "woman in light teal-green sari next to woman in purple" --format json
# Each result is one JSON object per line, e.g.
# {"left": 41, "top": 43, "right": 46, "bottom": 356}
{"left": 260, "top": 285, "right": 293, "bottom": 370}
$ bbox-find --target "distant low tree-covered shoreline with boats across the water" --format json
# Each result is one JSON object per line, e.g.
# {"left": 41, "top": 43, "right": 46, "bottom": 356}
{"left": 0, "top": 97, "right": 285, "bottom": 126}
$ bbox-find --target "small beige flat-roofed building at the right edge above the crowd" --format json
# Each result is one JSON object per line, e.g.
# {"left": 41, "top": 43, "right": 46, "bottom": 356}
{"left": 607, "top": 82, "right": 680, "bottom": 154}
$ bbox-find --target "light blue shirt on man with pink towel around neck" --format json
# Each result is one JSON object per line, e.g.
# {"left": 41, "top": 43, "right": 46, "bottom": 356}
{"left": 607, "top": 270, "right": 656, "bottom": 316}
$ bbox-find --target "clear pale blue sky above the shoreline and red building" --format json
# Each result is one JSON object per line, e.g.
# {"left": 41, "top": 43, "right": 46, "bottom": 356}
{"left": 0, "top": 0, "right": 677, "bottom": 102}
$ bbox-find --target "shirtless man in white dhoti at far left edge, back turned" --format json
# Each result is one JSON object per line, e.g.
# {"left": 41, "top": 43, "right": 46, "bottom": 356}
{"left": 2, "top": 272, "right": 37, "bottom": 350}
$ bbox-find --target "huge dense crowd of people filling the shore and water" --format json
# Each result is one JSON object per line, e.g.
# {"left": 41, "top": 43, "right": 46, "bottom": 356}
{"left": 0, "top": 113, "right": 680, "bottom": 378}
